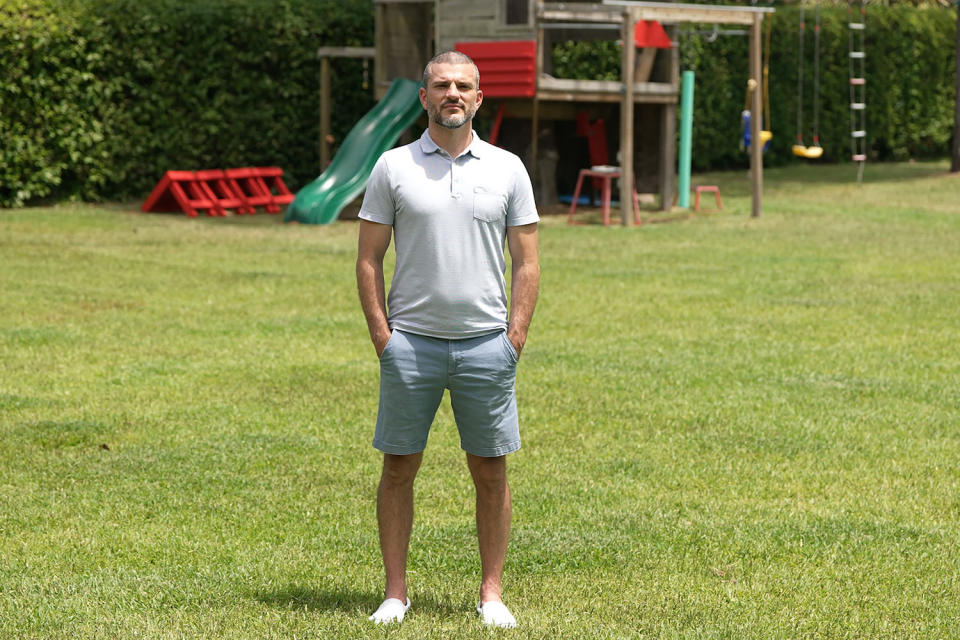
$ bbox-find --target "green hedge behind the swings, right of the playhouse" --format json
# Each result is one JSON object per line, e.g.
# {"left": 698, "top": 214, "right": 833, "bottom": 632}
{"left": 553, "top": 6, "right": 956, "bottom": 170}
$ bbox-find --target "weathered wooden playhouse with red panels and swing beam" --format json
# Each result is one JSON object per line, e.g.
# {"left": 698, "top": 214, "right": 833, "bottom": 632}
{"left": 356, "top": 0, "right": 773, "bottom": 225}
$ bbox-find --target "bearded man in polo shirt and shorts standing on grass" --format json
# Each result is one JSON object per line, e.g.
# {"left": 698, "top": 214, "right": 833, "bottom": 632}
{"left": 357, "top": 51, "right": 540, "bottom": 627}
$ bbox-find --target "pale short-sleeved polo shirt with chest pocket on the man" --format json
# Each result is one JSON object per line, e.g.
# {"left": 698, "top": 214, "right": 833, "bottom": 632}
{"left": 360, "top": 131, "right": 540, "bottom": 339}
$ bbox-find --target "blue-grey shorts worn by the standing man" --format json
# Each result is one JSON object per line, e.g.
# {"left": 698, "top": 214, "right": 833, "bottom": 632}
{"left": 373, "top": 329, "right": 520, "bottom": 457}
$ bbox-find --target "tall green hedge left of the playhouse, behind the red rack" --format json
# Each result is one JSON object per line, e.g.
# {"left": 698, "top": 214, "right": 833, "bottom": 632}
{"left": 0, "top": 0, "right": 373, "bottom": 206}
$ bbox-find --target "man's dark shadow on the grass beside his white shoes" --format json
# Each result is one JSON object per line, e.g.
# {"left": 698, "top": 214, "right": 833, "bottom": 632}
{"left": 253, "top": 585, "right": 456, "bottom": 613}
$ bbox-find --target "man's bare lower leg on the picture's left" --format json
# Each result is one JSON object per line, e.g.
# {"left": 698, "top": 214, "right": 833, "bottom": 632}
{"left": 377, "top": 453, "right": 423, "bottom": 602}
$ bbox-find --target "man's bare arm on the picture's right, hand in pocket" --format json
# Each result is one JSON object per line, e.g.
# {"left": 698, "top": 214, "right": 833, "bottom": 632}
{"left": 507, "top": 223, "right": 540, "bottom": 355}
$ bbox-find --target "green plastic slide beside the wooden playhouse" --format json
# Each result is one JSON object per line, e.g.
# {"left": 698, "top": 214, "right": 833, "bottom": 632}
{"left": 284, "top": 78, "right": 423, "bottom": 224}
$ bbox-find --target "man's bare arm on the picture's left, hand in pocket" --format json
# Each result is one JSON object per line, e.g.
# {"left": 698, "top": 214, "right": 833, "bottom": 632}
{"left": 357, "top": 220, "right": 393, "bottom": 358}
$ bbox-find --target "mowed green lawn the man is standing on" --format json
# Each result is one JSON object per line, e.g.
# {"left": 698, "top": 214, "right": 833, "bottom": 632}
{"left": 0, "top": 163, "right": 960, "bottom": 639}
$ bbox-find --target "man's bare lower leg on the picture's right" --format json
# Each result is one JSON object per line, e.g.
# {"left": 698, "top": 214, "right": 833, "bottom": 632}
{"left": 467, "top": 453, "right": 512, "bottom": 603}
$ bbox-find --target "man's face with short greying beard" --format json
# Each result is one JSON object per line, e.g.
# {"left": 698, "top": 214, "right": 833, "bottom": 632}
{"left": 420, "top": 63, "right": 483, "bottom": 129}
